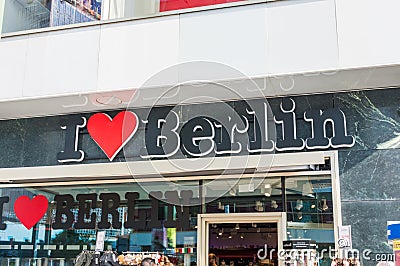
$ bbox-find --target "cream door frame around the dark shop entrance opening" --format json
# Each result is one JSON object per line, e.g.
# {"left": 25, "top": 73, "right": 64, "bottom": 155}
{"left": 197, "top": 212, "right": 287, "bottom": 266}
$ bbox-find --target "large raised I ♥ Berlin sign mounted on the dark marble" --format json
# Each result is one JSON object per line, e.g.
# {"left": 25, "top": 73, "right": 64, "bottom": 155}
{"left": 57, "top": 99, "right": 354, "bottom": 163}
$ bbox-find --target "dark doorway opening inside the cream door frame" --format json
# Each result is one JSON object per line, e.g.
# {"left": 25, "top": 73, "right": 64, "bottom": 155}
{"left": 208, "top": 222, "right": 278, "bottom": 266}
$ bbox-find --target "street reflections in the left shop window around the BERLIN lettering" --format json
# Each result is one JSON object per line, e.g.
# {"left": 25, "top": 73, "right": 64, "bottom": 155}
{"left": 0, "top": 182, "right": 200, "bottom": 266}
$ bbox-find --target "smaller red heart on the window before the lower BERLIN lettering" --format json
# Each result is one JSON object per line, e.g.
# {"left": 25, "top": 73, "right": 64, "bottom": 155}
{"left": 14, "top": 195, "right": 49, "bottom": 230}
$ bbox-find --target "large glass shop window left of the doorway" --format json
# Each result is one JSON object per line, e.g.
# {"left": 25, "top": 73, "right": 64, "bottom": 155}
{"left": 0, "top": 183, "right": 200, "bottom": 266}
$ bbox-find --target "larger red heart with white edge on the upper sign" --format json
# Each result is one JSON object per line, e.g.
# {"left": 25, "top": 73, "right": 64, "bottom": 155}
{"left": 87, "top": 111, "right": 139, "bottom": 161}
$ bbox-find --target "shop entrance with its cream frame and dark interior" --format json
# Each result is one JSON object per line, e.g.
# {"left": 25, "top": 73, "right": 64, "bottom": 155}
{"left": 197, "top": 212, "right": 286, "bottom": 266}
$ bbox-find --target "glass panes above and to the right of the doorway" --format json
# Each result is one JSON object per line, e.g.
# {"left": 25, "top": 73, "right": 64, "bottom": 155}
{"left": 205, "top": 175, "right": 335, "bottom": 265}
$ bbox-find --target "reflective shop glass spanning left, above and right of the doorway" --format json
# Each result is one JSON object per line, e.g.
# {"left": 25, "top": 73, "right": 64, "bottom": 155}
{"left": 0, "top": 175, "right": 334, "bottom": 266}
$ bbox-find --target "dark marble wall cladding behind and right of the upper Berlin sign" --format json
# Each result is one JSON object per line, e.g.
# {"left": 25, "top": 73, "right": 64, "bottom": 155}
{"left": 0, "top": 89, "right": 400, "bottom": 265}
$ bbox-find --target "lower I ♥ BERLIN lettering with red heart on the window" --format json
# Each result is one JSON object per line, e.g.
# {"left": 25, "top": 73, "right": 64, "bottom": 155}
{"left": 0, "top": 190, "right": 193, "bottom": 230}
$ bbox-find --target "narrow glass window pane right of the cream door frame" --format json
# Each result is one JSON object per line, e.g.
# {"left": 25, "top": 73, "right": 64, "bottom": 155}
{"left": 285, "top": 175, "right": 335, "bottom": 265}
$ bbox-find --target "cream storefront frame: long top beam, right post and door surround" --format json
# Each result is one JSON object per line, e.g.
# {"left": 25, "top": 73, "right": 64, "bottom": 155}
{"left": 0, "top": 151, "right": 342, "bottom": 266}
